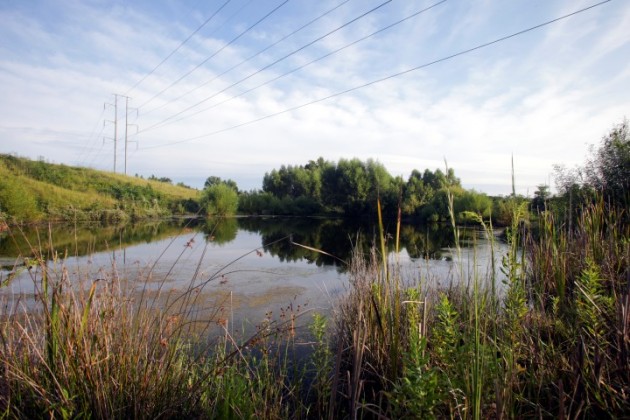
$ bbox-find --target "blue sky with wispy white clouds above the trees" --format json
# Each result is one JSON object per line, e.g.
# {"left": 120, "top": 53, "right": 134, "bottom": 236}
{"left": 0, "top": 0, "right": 630, "bottom": 196}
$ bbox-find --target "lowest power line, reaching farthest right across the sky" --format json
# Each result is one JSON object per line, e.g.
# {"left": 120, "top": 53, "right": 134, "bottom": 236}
{"left": 144, "top": 0, "right": 612, "bottom": 149}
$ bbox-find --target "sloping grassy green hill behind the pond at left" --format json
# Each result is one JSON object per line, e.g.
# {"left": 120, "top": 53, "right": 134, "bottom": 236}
{"left": 0, "top": 154, "right": 199, "bottom": 222}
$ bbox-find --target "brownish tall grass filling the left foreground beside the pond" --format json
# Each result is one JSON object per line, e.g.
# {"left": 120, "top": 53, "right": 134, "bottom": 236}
{"left": 0, "top": 223, "right": 314, "bottom": 419}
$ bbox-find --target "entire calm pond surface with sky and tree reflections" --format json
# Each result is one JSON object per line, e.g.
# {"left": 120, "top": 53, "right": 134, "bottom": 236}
{"left": 0, "top": 217, "right": 506, "bottom": 329}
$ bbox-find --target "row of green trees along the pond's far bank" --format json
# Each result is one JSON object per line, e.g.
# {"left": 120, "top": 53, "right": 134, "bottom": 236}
{"left": 201, "top": 157, "right": 493, "bottom": 221}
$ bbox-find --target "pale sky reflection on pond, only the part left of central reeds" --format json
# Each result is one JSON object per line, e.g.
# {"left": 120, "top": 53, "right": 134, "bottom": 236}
{"left": 0, "top": 230, "right": 347, "bottom": 332}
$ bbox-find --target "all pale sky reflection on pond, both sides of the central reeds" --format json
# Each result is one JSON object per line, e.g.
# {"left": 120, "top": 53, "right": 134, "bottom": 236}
{"left": 0, "top": 223, "right": 506, "bottom": 329}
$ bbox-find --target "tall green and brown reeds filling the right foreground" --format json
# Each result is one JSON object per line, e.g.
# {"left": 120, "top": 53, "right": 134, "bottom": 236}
{"left": 328, "top": 195, "right": 630, "bottom": 419}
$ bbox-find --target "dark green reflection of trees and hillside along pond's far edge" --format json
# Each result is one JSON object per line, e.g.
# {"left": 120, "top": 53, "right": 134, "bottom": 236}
{"left": 0, "top": 217, "right": 494, "bottom": 271}
